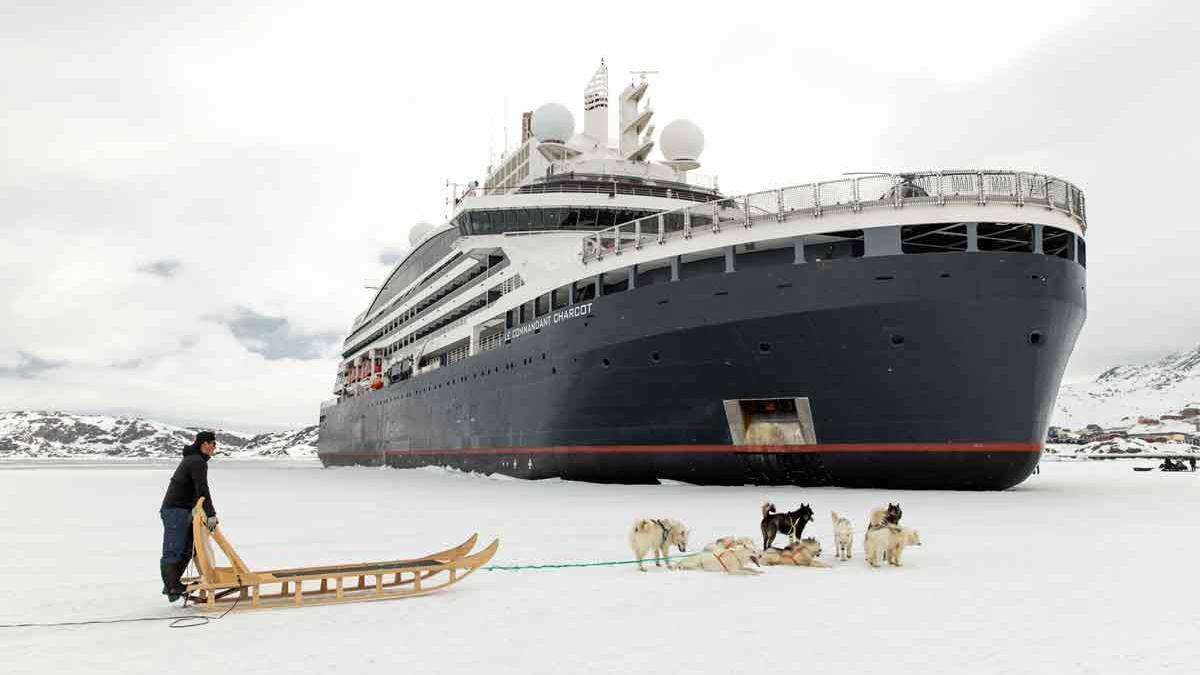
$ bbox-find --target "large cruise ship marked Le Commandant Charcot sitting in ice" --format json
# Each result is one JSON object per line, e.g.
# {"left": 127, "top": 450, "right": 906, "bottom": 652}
{"left": 317, "top": 62, "right": 1087, "bottom": 490}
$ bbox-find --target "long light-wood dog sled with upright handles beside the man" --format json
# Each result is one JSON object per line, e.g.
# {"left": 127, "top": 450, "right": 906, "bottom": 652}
{"left": 182, "top": 497, "right": 500, "bottom": 611}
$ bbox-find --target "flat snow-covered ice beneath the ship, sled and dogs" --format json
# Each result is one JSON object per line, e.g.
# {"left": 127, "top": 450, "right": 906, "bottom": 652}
{"left": 0, "top": 460, "right": 1200, "bottom": 675}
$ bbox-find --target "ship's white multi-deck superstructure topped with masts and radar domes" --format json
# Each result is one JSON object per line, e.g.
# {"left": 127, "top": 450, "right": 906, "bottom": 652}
{"left": 335, "top": 61, "right": 720, "bottom": 396}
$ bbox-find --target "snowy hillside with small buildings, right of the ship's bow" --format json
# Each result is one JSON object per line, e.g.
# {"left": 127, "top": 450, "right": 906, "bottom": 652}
{"left": 1051, "top": 347, "right": 1200, "bottom": 429}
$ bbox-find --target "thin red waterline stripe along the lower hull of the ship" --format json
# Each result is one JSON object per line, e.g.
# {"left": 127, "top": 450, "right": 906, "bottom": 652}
{"left": 320, "top": 443, "right": 1042, "bottom": 458}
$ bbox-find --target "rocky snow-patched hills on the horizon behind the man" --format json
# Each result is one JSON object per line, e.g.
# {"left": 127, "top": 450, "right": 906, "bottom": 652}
{"left": 0, "top": 411, "right": 317, "bottom": 459}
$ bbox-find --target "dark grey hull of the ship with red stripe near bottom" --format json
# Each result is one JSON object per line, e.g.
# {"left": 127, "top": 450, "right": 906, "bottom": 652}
{"left": 318, "top": 252, "right": 1086, "bottom": 489}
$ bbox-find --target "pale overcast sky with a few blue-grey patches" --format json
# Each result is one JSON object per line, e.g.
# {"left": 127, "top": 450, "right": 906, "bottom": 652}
{"left": 0, "top": 0, "right": 1200, "bottom": 430}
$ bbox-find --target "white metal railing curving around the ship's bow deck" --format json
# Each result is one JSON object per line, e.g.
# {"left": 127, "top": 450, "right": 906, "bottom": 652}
{"left": 580, "top": 169, "right": 1087, "bottom": 263}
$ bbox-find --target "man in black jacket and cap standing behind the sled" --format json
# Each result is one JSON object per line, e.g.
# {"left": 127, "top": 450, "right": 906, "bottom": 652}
{"left": 158, "top": 431, "right": 217, "bottom": 602}
